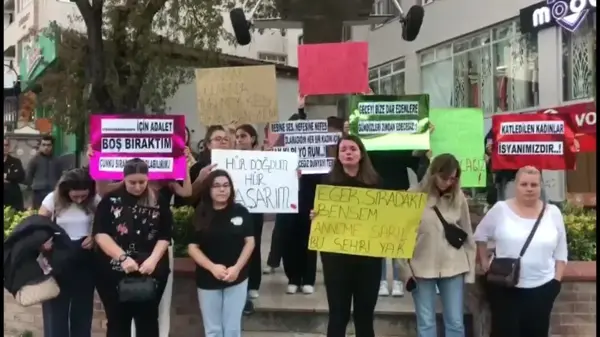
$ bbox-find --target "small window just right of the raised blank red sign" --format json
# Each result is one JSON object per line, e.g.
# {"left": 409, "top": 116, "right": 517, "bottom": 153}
{"left": 369, "top": 59, "right": 405, "bottom": 95}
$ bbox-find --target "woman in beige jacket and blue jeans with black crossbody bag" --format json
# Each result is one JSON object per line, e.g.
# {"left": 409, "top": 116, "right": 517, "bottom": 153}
{"left": 399, "top": 153, "right": 475, "bottom": 337}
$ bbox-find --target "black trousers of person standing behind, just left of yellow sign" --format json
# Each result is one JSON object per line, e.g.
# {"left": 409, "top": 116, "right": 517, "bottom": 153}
{"left": 282, "top": 213, "right": 317, "bottom": 286}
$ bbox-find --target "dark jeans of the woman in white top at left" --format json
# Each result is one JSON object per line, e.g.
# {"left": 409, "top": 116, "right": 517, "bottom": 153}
{"left": 42, "top": 240, "right": 95, "bottom": 337}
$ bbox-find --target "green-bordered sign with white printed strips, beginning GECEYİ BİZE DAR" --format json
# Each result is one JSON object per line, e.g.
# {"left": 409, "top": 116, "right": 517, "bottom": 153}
{"left": 348, "top": 95, "right": 429, "bottom": 151}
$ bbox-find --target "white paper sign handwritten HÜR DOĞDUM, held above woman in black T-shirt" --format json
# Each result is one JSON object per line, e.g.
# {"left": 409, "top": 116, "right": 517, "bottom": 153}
{"left": 211, "top": 150, "right": 298, "bottom": 213}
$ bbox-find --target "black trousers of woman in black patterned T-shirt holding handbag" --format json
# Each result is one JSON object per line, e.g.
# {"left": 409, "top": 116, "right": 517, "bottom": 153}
{"left": 96, "top": 277, "right": 167, "bottom": 337}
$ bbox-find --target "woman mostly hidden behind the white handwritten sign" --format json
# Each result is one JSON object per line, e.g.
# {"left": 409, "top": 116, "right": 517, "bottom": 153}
{"left": 235, "top": 124, "right": 264, "bottom": 299}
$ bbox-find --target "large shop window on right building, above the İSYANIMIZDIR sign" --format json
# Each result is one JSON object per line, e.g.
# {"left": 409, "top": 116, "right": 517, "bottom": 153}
{"left": 420, "top": 21, "right": 539, "bottom": 114}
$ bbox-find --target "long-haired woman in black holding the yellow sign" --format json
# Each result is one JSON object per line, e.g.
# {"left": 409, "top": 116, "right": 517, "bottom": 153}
{"left": 310, "top": 135, "right": 382, "bottom": 337}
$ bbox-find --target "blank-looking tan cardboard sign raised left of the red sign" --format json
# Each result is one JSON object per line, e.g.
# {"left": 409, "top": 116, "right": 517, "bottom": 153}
{"left": 196, "top": 65, "right": 279, "bottom": 125}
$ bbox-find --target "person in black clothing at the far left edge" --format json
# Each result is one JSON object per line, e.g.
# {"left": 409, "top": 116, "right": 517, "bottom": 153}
{"left": 4, "top": 138, "right": 25, "bottom": 211}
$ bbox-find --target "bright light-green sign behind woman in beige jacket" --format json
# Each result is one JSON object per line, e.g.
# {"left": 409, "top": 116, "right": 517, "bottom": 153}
{"left": 429, "top": 108, "right": 486, "bottom": 187}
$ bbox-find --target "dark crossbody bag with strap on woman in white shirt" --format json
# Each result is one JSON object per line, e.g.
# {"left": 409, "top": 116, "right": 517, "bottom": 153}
{"left": 485, "top": 203, "right": 546, "bottom": 288}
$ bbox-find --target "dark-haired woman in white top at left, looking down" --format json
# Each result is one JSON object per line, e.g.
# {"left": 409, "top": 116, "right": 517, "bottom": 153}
{"left": 39, "top": 169, "right": 100, "bottom": 337}
